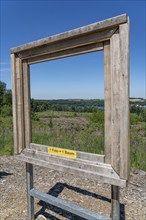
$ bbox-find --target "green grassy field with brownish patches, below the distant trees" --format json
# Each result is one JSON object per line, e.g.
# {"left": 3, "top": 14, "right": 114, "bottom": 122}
{"left": 0, "top": 110, "right": 146, "bottom": 171}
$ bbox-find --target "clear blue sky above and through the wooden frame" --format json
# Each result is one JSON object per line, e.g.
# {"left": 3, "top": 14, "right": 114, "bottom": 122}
{"left": 0, "top": 0, "right": 146, "bottom": 99}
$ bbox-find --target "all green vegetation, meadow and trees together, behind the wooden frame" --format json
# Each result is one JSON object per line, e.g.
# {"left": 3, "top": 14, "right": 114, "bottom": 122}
{"left": 0, "top": 82, "right": 146, "bottom": 171}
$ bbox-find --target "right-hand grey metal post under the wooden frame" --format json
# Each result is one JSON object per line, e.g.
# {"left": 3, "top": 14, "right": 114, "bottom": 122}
{"left": 111, "top": 185, "right": 120, "bottom": 220}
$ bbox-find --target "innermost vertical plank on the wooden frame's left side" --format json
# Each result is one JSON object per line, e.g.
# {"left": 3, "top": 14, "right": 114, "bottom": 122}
{"left": 23, "top": 61, "right": 31, "bottom": 148}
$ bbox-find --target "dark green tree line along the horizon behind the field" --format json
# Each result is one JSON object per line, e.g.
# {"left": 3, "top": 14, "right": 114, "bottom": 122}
{"left": 0, "top": 81, "right": 146, "bottom": 119}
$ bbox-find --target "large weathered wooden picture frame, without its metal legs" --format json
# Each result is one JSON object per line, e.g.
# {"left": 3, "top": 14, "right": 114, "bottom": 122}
{"left": 11, "top": 14, "right": 129, "bottom": 187}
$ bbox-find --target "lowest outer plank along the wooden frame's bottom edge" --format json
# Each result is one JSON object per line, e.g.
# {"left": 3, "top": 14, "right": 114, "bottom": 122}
{"left": 16, "top": 153, "right": 126, "bottom": 187}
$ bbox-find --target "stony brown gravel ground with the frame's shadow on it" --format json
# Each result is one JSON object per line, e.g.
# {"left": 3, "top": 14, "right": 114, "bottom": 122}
{"left": 0, "top": 157, "right": 146, "bottom": 220}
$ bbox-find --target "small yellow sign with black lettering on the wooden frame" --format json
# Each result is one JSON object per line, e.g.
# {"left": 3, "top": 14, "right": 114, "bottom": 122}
{"left": 48, "top": 147, "right": 77, "bottom": 159}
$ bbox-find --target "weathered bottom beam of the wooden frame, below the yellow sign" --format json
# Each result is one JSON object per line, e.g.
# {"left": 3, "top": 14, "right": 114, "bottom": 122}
{"left": 17, "top": 149, "right": 126, "bottom": 187}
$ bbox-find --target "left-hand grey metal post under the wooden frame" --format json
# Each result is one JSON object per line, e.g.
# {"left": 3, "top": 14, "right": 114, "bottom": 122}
{"left": 26, "top": 163, "right": 34, "bottom": 220}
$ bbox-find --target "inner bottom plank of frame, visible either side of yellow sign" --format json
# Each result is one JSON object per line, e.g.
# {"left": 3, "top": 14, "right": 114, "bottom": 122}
{"left": 30, "top": 143, "right": 104, "bottom": 163}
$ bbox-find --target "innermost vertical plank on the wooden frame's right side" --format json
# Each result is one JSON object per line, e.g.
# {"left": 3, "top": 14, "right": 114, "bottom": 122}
{"left": 104, "top": 41, "right": 111, "bottom": 163}
